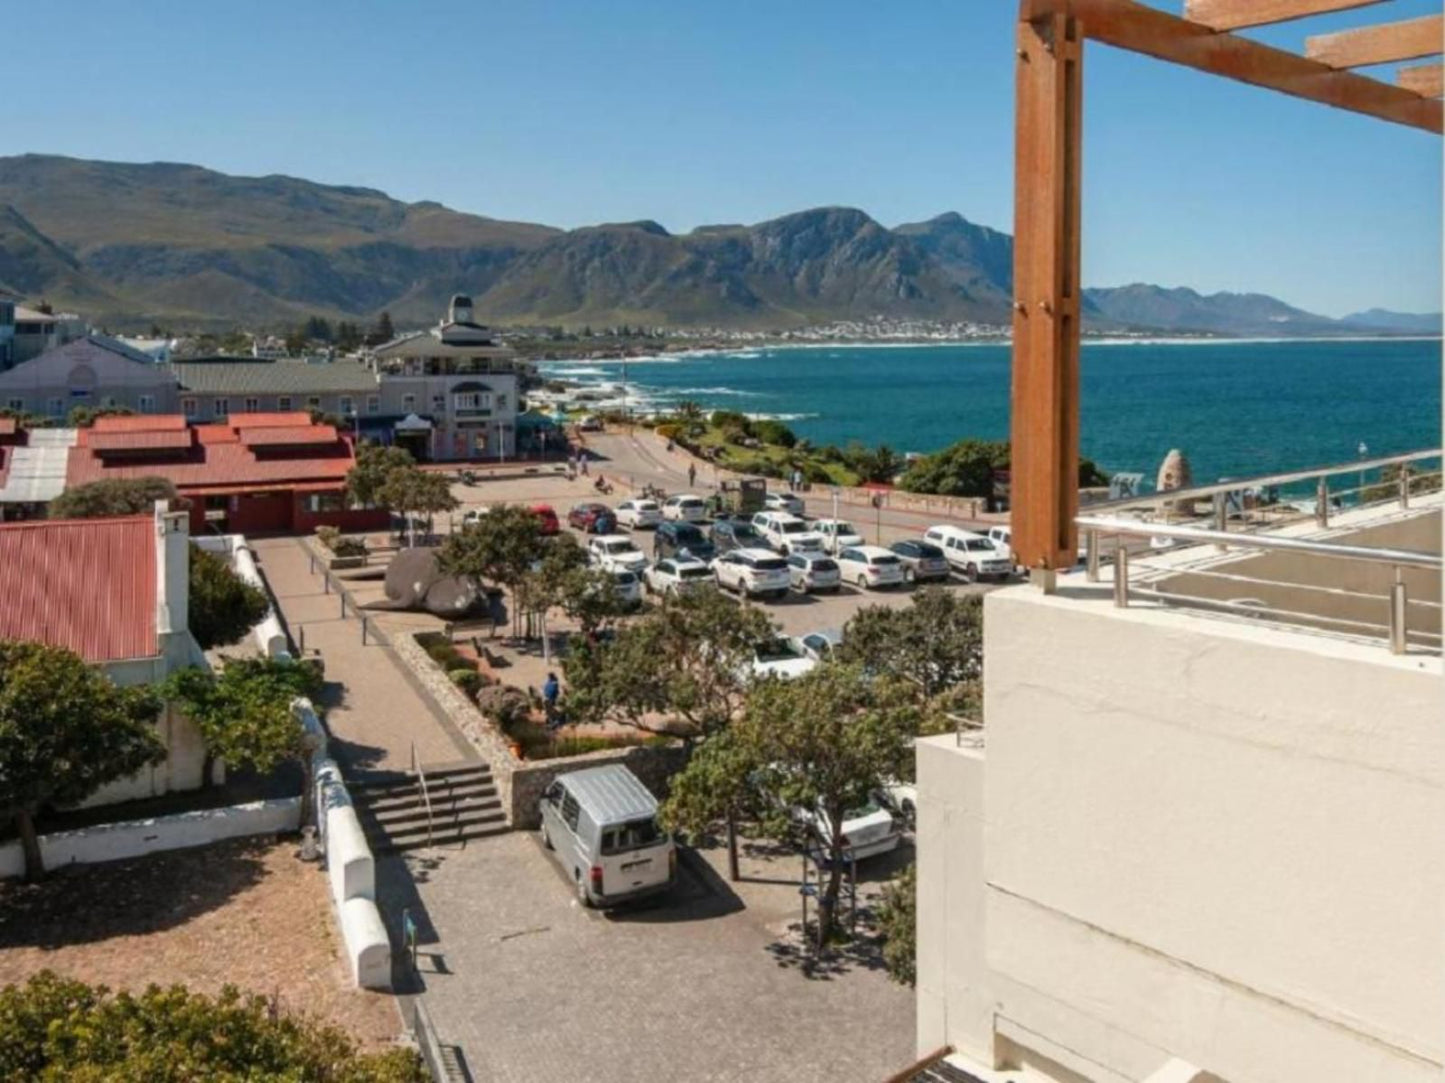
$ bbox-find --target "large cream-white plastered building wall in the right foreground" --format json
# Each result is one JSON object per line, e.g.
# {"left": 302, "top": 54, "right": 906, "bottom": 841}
{"left": 936, "top": 587, "right": 1445, "bottom": 1083}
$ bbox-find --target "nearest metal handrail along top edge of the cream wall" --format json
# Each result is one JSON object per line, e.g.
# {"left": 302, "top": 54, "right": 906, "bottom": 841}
{"left": 1075, "top": 515, "right": 1442, "bottom": 655}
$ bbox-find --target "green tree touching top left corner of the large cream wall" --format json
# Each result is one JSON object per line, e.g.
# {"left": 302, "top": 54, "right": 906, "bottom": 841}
{"left": 838, "top": 587, "right": 984, "bottom": 698}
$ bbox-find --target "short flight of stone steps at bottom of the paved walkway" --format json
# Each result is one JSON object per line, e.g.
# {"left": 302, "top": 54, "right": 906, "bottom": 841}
{"left": 347, "top": 761, "right": 509, "bottom": 853}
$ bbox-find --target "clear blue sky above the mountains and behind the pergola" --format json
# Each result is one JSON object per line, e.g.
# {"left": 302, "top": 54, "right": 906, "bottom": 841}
{"left": 0, "top": 0, "right": 1441, "bottom": 315}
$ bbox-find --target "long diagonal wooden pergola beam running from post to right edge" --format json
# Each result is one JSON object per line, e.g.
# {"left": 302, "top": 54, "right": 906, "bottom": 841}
{"left": 1019, "top": 0, "right": 1445, "bottom": 133}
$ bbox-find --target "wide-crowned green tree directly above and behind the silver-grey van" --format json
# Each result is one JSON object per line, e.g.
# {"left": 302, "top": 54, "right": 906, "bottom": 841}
{"left": 562, "top": 590, "right": 777, "bottom": 739}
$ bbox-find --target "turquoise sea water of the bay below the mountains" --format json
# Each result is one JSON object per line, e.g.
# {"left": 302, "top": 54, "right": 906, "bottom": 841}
{"left": 543, "top": 340, "right": 1441, "bottom": 483}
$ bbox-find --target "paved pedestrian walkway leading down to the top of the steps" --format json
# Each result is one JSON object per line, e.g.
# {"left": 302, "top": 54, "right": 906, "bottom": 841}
{"left": 251, "top": 538, "right": 477, "bottom": 774}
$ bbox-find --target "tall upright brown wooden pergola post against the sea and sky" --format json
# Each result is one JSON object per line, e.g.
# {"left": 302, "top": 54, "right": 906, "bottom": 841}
{"left": 1010, "top": 10, "right": 1084, "bottom": 570}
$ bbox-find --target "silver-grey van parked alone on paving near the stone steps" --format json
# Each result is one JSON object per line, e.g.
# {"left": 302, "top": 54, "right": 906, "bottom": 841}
{"left": 540, "top": 763, "right": 678, "bottom": 907}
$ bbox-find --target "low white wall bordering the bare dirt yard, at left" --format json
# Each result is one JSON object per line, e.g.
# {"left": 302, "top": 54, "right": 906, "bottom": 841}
{"left": 0, "top": 797, "right": 301, "bottom": 878}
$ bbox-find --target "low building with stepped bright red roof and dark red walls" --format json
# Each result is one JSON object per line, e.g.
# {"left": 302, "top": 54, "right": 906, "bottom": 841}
{"left": 65, "top": 412, "right": 387, "bottom": 534}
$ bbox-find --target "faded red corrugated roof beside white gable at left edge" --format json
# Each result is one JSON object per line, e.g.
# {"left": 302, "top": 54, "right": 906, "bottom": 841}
{"left": 0, "top": 515, "right": 158, "bottom": 662}
